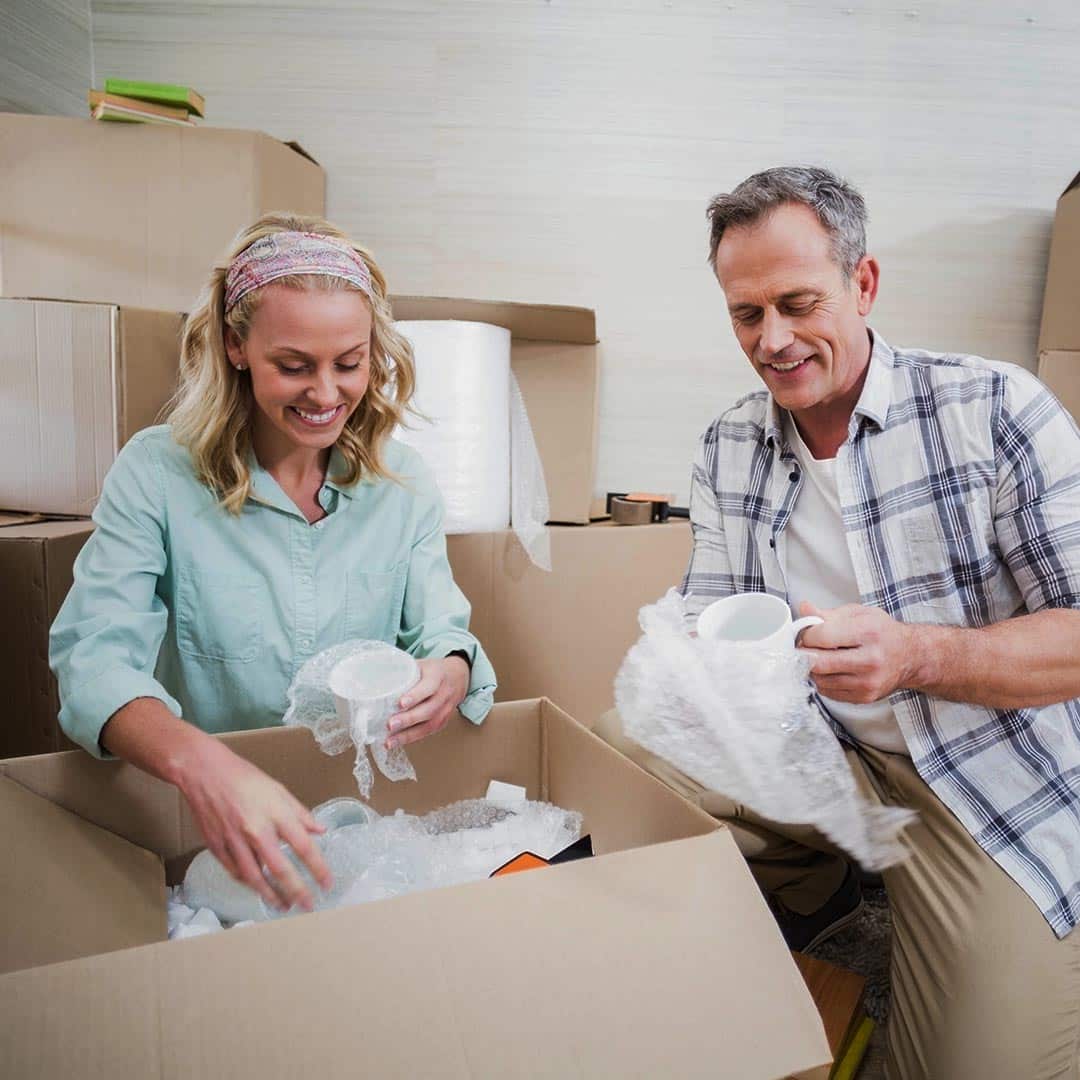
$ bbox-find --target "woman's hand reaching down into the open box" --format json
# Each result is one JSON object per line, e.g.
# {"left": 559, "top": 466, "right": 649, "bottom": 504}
{"left": 167, "top": 737, "right": 330, "bottom": 910}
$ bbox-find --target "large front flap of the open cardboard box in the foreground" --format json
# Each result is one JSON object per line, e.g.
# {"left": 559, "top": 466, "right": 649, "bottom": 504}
{"left": 0, "top": 831, "right": 829, "bottom": 1080}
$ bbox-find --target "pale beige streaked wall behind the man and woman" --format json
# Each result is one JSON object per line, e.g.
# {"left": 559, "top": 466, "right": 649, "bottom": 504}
{"left": 93, "top": 0, "right": 1080, "bottom": 499}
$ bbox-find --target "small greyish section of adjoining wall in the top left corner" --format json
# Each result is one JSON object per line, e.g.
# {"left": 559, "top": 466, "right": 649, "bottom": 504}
{"left": 0, "top": 0, "right": 93, "bottom": 117}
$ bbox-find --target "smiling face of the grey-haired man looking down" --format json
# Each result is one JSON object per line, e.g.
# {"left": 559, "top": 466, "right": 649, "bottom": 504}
{"left": 716, "top": 203, "right": 878, "bottom": 420}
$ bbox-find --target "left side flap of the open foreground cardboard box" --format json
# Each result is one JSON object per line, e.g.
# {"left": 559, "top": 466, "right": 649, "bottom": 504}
{"left": 0, "top": 777, "right": 166, "bottom": 976}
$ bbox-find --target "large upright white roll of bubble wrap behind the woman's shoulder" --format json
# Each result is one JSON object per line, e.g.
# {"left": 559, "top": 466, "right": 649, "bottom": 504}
{"left": 394, "top": 320, "right": 551, "bottom": 570}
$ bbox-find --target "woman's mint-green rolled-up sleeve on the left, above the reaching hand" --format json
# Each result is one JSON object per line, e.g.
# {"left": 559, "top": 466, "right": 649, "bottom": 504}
{"left": 49, "top": 436, "right": 180, "bottom": 757}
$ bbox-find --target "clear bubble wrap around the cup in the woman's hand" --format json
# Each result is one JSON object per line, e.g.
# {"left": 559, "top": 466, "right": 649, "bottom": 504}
{"left": 282, "top": 640, "right": 419, "bottom": 798}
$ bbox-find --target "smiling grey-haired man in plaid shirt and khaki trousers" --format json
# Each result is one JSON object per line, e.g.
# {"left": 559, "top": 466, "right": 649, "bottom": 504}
{"left": 602, "top": 168, "right": 1080, "bottom": 1080}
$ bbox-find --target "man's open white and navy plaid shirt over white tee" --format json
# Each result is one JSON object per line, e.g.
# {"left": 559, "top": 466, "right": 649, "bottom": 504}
{"left": 681, "top": 335, "right": 1080, "bottom": 937}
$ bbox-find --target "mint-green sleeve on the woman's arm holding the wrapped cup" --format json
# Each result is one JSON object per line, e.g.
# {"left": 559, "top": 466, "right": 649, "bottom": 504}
{"left": 397, "top": 471, "right": 497, "bottom": 724}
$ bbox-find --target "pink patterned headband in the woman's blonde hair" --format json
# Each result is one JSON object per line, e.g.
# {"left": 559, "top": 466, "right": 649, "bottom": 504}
{"left": 225, "top": 232, "right": 373, "bottom": 313}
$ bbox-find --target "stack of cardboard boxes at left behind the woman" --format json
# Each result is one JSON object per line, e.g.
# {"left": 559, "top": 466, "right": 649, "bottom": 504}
{"left": 0, "top": 114, "right": 325, "bottom": 756}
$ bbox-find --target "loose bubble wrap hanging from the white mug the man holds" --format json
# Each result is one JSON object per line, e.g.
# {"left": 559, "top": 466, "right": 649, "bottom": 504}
{"left": 615, "top": 590, "right": 916, "bottom": 869}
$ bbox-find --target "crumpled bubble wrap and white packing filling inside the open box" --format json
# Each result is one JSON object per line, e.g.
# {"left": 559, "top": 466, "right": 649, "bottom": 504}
{"left": 168, "top": 799, "right": 582, "bottom": 939}
